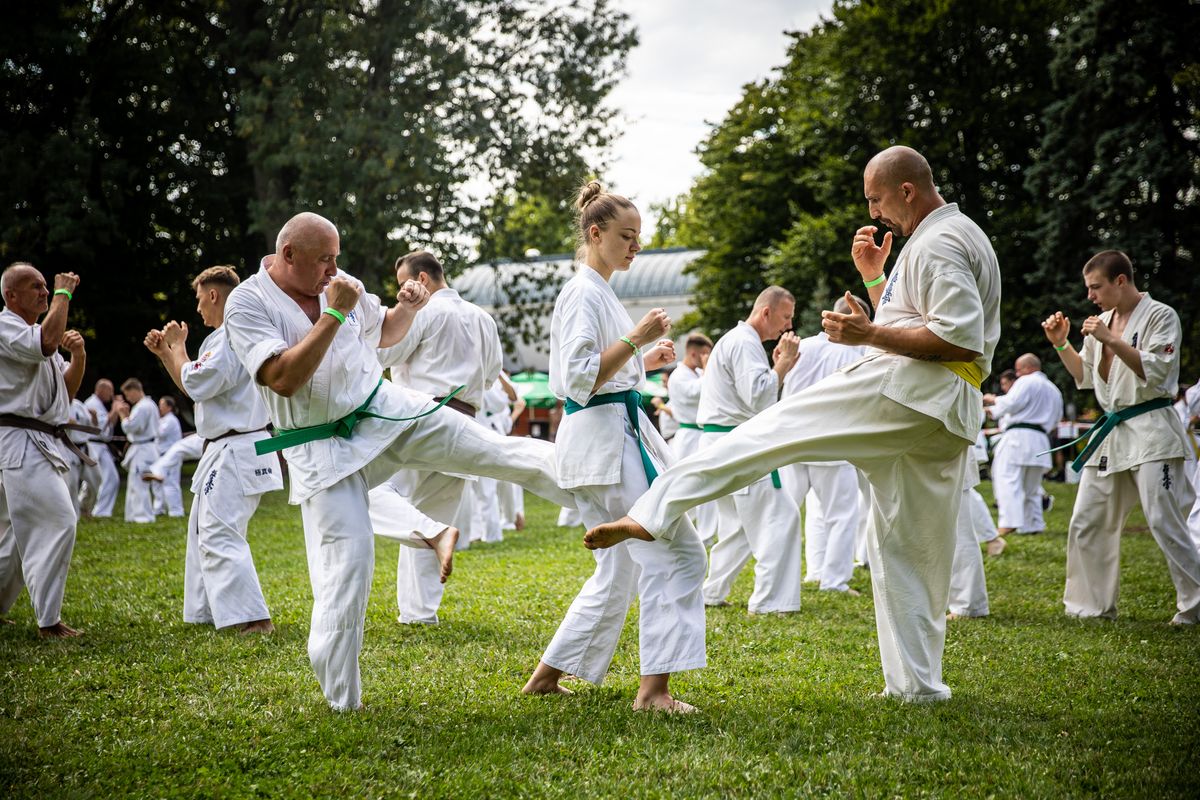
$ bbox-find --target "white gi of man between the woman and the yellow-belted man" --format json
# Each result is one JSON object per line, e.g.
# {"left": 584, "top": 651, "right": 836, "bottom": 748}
{"left": 696, "top": 321, "right": 802, "bottom": 614}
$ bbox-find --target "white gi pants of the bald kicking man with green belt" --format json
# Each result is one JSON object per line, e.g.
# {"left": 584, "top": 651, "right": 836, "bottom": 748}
{"left": 300, "top": 409, "right": 575, "bottom": 710}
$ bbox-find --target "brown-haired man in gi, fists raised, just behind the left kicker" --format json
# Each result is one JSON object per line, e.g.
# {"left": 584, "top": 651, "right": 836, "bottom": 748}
{"left": 145, "top": 266, "right": 283, "bottom": 633}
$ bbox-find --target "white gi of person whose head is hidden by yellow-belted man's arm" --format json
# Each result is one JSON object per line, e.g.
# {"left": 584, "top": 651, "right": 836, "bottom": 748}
{"left": 780, "top": 331, "right": 866, "bottom": 591}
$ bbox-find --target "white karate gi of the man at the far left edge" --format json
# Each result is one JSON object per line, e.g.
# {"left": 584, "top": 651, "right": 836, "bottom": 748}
{"left": 0, "top": 308, "right": 77, "bottom": 627}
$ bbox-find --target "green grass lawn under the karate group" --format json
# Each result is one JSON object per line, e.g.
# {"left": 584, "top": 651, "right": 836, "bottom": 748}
{"left": 0, "top": 485, "right": 1200, "bottom": 798}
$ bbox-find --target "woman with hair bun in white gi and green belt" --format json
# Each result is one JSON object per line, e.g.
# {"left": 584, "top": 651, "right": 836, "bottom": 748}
{"left": 524, "top": 181, "right": 706, "bottom": 714}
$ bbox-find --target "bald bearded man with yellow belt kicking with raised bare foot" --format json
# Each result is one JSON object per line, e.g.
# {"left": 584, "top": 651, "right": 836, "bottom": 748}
{"left": 584, "top": 146, "right": 1000, "bottom": 702}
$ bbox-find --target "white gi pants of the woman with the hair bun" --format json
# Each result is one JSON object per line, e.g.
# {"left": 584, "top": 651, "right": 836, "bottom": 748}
{"left": 541, "top": 423, "right": 707, "bottom": 685}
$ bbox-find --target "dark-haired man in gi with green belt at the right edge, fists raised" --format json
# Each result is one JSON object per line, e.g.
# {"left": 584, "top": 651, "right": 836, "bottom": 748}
{"left": 1041, "top": 251, "right": 1200, "bottom": 625}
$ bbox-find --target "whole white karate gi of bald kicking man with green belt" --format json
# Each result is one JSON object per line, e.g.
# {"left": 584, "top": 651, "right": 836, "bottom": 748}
{"left": 224, "top": 261, "right": 575, "bottom": 709}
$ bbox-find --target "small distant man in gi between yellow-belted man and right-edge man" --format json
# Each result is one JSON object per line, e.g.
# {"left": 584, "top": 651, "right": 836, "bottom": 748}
{"left": 983, "top": 353, "right": 1062, "bottom": 536}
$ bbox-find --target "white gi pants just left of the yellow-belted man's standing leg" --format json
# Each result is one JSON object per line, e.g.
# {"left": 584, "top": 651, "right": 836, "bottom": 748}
{"left": 779, "top": 464, "right": 863, "bottom": 591}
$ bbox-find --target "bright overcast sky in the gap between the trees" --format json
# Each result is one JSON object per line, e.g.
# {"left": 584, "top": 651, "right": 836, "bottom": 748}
{"left": 607, "top": 0, "right": 833, "bottom": 230}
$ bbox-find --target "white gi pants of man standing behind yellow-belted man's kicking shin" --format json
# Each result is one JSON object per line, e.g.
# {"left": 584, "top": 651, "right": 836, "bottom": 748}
{"left": 696, "top": 433, "right": 802, "bottom": 614}
